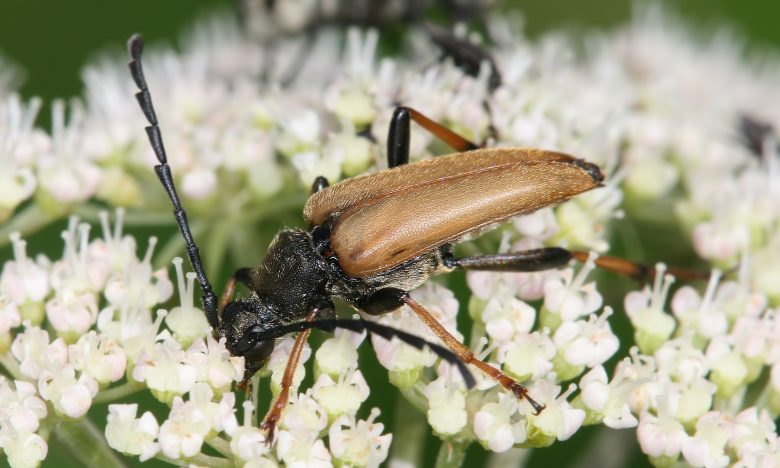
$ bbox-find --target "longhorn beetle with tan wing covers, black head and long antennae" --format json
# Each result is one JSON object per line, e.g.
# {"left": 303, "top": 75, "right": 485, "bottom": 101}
{"left": 128, "top": 34, "right": 664, "bottom": 441}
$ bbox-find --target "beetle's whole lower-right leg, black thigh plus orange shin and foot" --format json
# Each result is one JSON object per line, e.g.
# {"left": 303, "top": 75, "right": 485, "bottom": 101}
{"left": 358, "top": 288, "right": 545, "bottom": 414}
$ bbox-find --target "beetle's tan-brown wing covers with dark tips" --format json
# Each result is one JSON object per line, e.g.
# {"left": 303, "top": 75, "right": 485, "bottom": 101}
{"left": 304, "top": 148, "right": 602, "bottom": 277}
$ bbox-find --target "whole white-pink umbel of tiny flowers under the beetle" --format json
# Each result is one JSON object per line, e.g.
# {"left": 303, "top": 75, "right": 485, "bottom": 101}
{"left": 0, "top": 4, "right": 780, "bottom": 467}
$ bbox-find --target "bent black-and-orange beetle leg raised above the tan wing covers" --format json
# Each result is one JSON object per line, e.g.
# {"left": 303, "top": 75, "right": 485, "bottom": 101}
{"left": 387, "top": 106, "right": 479, "bottom": 167}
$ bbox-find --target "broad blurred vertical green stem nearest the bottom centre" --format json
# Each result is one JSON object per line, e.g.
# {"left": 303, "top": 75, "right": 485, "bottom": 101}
{"left": 390, "top": 395, "right": 428, "bottom": 466}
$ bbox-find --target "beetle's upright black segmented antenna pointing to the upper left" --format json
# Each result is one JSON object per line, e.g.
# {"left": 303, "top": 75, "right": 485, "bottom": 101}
{"left": 127, "top": 34, "right": 219, "bottom": 332}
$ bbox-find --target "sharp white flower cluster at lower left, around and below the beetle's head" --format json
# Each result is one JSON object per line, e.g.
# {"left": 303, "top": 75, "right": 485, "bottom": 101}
{"left": 0, "top": 215, "right": 392, "bottom": 467}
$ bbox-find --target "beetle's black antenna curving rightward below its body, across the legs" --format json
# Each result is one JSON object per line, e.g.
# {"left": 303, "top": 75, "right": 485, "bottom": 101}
{"left": 256, "top": 319, "right": 477, "bottom": 388}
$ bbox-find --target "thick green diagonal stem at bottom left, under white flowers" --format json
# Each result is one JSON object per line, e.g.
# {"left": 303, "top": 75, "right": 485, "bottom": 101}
{"left": 51, "top": 419, "right": 125, "bottom": 468}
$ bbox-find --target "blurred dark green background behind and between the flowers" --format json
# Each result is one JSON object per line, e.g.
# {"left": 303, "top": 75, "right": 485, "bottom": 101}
{"left": 0, "top": 0, "right": 780, "bottom": 466}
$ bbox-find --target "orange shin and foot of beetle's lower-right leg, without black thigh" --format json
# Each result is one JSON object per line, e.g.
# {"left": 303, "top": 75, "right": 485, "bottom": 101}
{"left": 399, "top": 293, "right": 545, "bottom": 415}
